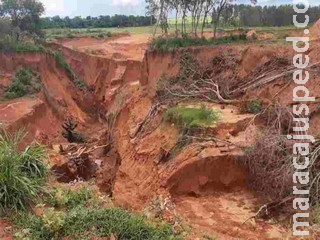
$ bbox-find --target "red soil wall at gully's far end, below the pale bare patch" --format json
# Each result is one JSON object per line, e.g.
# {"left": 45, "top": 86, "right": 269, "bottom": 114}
{"left": 51, "top": 44, "right": 142, "bottom": 102}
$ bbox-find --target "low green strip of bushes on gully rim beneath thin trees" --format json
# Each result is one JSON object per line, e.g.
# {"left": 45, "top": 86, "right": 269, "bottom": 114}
{"left": 149, "top": 34, "right": 247, "bottom": 51}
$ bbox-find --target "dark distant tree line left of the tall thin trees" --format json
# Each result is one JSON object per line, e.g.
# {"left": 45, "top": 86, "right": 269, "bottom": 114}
{"left": 40, "top": 15, "right": 156, "bottom": 29}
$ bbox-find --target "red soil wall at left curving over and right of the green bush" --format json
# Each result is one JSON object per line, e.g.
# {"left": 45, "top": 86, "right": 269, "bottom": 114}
{"left": 0, "top": 53, "right": 88, "bottom": 122}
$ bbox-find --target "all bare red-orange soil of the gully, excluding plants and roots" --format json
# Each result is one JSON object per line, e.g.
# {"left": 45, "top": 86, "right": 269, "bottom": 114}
{"left": 0, "top": 36, "right": 320, "bottom": 239}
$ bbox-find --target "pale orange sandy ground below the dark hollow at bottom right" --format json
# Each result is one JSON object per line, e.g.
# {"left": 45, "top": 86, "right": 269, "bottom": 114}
{"left": 176, "top": 191, "right": 289, "bottom": 240}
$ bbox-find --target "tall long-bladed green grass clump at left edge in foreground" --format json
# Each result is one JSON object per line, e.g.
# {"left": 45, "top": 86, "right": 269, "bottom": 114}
{"left": 0, "top": 132, "right": 47, "bottom": 212}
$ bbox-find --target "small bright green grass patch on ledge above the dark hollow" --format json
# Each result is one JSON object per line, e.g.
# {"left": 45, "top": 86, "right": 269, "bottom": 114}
{"left": 164, "top": 107, "right": 219, "bottom": 128}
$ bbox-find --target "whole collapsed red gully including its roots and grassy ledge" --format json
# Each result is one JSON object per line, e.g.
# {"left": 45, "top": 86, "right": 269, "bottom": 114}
{"left": 0, "top": 26, "right": 320, "bottom": 239}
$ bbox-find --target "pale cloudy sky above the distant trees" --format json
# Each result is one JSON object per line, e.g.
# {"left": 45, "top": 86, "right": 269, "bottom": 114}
{"left": 40, "top": 0, "right": 320, "bottom": 17}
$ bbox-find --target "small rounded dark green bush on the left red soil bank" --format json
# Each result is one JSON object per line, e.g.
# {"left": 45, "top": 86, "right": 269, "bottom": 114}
{"left": 4, "top": 68, "right": 41, "bottom": 99}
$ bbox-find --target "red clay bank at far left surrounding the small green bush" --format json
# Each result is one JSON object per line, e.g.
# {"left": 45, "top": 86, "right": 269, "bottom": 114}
{"left": 0, "top": 53, "right": 95, "bottom": 146}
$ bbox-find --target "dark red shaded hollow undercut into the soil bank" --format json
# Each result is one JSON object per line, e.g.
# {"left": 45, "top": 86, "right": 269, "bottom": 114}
{"left": 167, "top": 154, "right": 246, "bottom": 196}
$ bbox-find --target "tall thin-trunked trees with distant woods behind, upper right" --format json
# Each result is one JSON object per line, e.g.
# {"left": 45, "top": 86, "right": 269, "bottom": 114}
{"left": 145, "top": 0, "right": 320, "bottom": 37}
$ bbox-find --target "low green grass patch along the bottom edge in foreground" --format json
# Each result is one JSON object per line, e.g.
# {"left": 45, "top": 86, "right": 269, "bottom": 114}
{"left": 15, "top": 207, "right": 177, "bottom": 240}
